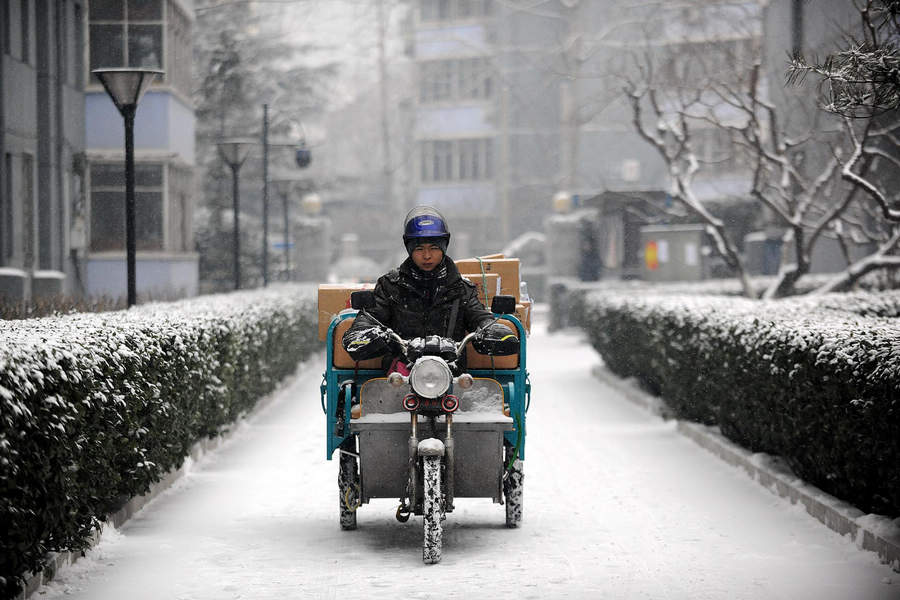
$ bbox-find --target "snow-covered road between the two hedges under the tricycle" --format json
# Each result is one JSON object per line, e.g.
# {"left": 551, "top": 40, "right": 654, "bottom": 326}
{"left": 35, "top": 316, "right": 900, "bottom": 600}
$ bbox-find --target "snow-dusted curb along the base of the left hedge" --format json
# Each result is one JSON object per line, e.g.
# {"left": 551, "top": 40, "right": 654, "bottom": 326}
{"left": 14, "top": 370, "right": 296, "bottom": 600}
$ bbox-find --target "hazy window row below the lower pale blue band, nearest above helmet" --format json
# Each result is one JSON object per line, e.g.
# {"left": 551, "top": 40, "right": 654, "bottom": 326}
{"left": 419, "top": 138, "right": 494, "bottom": 183}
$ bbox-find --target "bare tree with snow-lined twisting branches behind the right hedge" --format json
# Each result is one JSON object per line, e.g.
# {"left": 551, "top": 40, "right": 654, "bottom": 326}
{"left": 626, "top": 1, "right": 900, "bottom": 297}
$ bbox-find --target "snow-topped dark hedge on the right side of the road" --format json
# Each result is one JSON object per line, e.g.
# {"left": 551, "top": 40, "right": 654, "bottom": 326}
{"left": 578, "top": 291, "right": 900, "bottom": 517}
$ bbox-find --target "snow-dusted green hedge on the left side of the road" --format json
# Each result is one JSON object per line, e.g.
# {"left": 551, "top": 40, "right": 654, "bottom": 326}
{"left": 0, "top": 285, "right": 319, "bottom": 594}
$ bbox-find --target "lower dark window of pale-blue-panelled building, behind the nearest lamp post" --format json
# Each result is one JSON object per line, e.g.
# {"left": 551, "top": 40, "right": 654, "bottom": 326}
{"left": 91, "top": 162, "right": 163, "bottom": 252}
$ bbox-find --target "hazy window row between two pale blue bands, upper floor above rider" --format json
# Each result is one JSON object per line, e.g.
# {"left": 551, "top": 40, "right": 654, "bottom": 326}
{"left": 419, "top": 57, "right": 493, "bottom": 104}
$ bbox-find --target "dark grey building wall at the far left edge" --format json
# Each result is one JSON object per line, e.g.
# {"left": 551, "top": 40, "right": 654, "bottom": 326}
{"left": 0, "top": 0, "right": 87, "bottom": 300}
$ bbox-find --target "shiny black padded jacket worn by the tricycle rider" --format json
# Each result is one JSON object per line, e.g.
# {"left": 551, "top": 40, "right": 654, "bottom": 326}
{"left": 343, "top": 255, "right": 493, "bottom": 354}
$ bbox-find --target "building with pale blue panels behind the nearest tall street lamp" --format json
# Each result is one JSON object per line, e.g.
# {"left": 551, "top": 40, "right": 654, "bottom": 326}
{"left": 84, "top": 0, "right": 199, "bottom": 298}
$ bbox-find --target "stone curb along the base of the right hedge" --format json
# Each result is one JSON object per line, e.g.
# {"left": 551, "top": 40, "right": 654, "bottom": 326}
{"left": 591, "top": 365, "right": 900, "bottom": 572}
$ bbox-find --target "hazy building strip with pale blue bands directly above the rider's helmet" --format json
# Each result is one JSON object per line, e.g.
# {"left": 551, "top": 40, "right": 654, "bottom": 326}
{"left": 411, "top": 0, "right": 506, "bottom": 252}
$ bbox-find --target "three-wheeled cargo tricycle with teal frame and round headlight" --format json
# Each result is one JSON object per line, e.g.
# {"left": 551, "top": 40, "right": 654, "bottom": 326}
{"left": 321, "top": 291, "right": 531, "bottom": 563}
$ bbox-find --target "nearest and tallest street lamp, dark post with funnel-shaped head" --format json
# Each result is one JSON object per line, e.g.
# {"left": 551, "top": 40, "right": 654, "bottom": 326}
{"left": 91, "top": 68, "right": 164, "bottom": 307}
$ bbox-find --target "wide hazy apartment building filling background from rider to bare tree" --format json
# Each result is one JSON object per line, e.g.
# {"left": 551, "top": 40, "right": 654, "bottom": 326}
{"left": 413, "top": 0, "right": 761, "bottom": 262}
